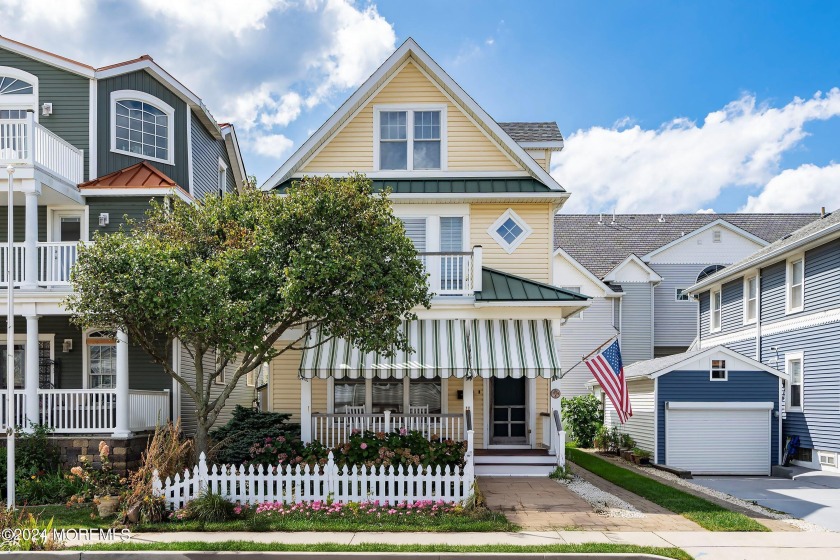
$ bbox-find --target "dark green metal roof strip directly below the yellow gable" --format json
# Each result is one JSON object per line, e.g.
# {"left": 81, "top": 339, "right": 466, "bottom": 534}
{"left": 276, "top": 177, "right": 561, "bottom": 194}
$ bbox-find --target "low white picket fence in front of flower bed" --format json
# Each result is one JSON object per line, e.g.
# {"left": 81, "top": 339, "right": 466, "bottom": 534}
{"left": 152, "top": 432, "right": 475, "bottom": 509}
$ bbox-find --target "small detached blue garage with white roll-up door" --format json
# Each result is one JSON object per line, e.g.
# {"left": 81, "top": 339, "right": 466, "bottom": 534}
{"left": 595, "top": 346, "right": 787, "bottom": 475}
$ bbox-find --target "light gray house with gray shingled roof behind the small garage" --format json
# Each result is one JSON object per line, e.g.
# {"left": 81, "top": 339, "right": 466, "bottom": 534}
{"left": 554, "top": 213, "right": 819, "bottom": 396}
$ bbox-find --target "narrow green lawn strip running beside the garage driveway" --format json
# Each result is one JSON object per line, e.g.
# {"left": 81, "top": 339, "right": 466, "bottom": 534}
{"left": 566, "top": 447, "right": 769, "bottom": 531}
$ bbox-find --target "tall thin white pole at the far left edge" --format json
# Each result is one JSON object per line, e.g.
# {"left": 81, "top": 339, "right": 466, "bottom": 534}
{"left": 6, "top": 162, "right": 15, "bottom": 509}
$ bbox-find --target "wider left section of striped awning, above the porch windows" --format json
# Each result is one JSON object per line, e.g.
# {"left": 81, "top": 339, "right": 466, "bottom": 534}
{"left": 300, "top": 319, "right": 469, "bottom": 379}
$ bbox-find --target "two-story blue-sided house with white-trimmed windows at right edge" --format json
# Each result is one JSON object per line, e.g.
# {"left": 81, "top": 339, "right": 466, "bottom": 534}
{"left": 689, "top": 212, "right": 840, "bottom": 471}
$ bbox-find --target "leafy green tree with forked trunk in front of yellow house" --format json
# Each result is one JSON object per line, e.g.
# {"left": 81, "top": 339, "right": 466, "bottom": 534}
{"left": 67, "top": 175, "right": 429, "bottom": 451}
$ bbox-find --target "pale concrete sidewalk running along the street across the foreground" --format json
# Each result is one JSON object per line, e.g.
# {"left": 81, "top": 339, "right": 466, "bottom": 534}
{"left": 67, "top": 531, "right": 840, "bottom": 560}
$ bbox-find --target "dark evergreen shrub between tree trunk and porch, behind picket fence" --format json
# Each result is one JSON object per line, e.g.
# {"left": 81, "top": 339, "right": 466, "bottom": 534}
{"left": 210, "top": 405, "right": 300, "bottom": 464}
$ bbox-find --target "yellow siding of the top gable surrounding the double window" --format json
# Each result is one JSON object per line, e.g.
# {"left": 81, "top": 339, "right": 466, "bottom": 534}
{"left": 301, "top": 62, "right": 522, "bottom": 173}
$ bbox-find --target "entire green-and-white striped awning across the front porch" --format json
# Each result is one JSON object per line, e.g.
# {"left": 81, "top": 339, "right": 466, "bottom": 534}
{"left": 300, "top": 319, "right": 560, "bottom": 379}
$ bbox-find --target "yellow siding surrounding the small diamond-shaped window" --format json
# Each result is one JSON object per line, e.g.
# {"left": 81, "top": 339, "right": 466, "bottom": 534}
{"left": 470, "top": 204, "right": 552, "bottom": 282}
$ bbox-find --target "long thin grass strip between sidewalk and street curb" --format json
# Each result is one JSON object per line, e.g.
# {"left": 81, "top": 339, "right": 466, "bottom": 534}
{"left": 73, "top": 541, "right": 691, "bottom": 560}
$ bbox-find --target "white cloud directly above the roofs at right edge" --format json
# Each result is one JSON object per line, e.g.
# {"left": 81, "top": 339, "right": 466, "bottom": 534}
{"left": 741, "top": 163, "right": 840, "bottom": 212}
